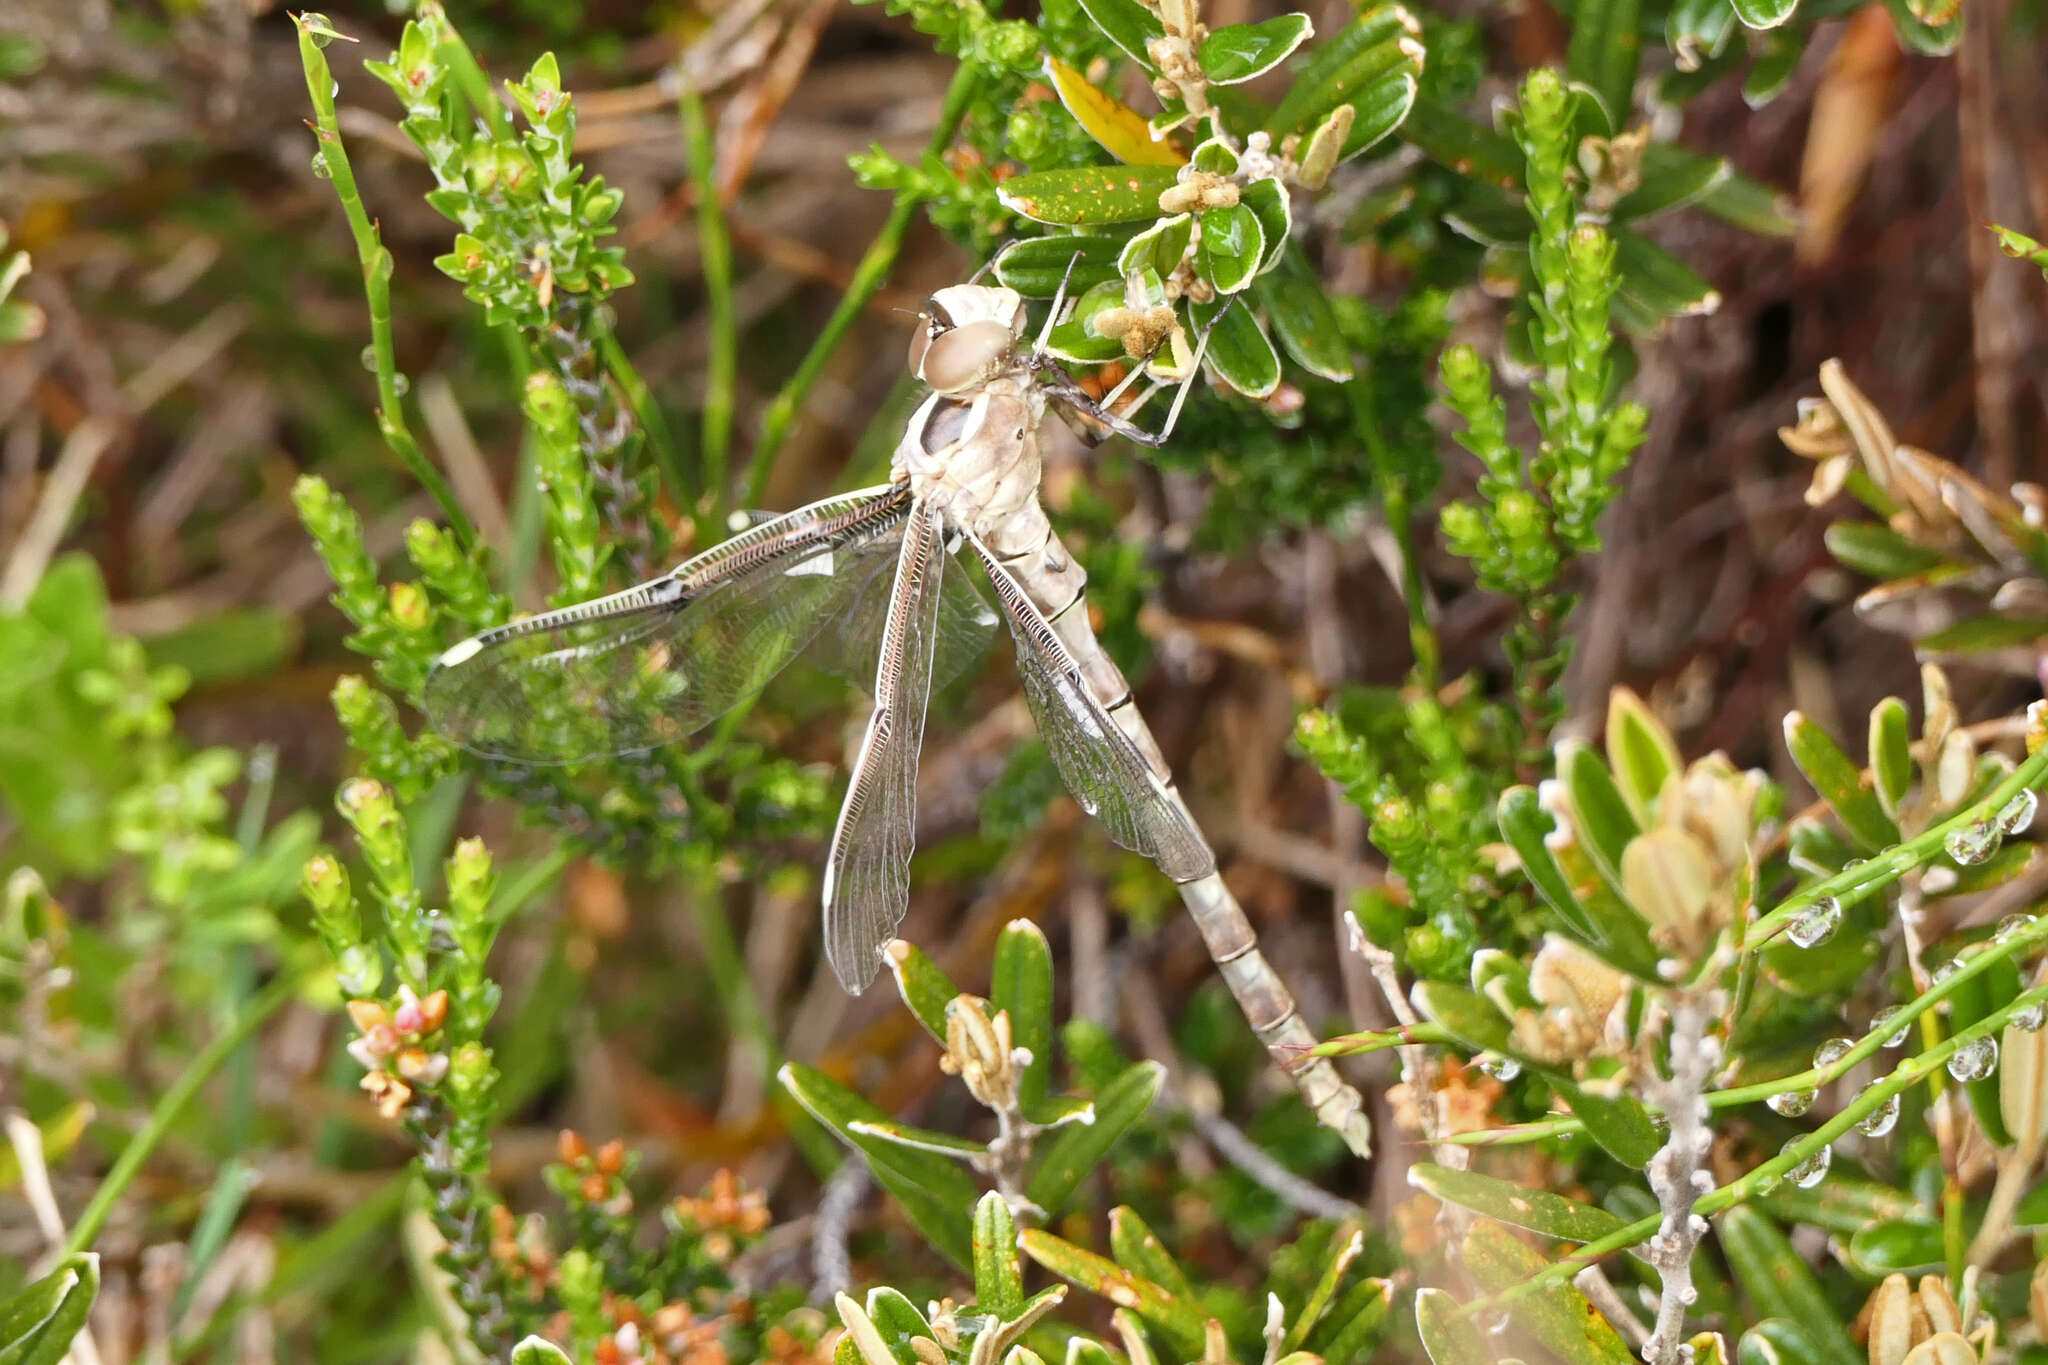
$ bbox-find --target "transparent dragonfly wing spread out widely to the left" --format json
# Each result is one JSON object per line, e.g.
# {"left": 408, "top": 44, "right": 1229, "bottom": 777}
{"left": 422, "top": 485, "right": 909, "bottom": 763}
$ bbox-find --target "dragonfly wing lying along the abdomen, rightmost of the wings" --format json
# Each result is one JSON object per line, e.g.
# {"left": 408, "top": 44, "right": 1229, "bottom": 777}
{"left": 973, "top": 527, "right": 1217, "bottom": 882}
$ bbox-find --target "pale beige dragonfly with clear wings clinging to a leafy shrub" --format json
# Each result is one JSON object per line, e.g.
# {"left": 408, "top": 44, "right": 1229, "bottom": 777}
{"left": 424, "top": 282, "right": 1370, "bottom": 1154}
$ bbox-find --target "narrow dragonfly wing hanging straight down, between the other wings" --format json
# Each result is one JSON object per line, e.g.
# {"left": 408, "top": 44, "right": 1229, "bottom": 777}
{"left": 825, "top": 503, "right": 946, "bottom": 995}
